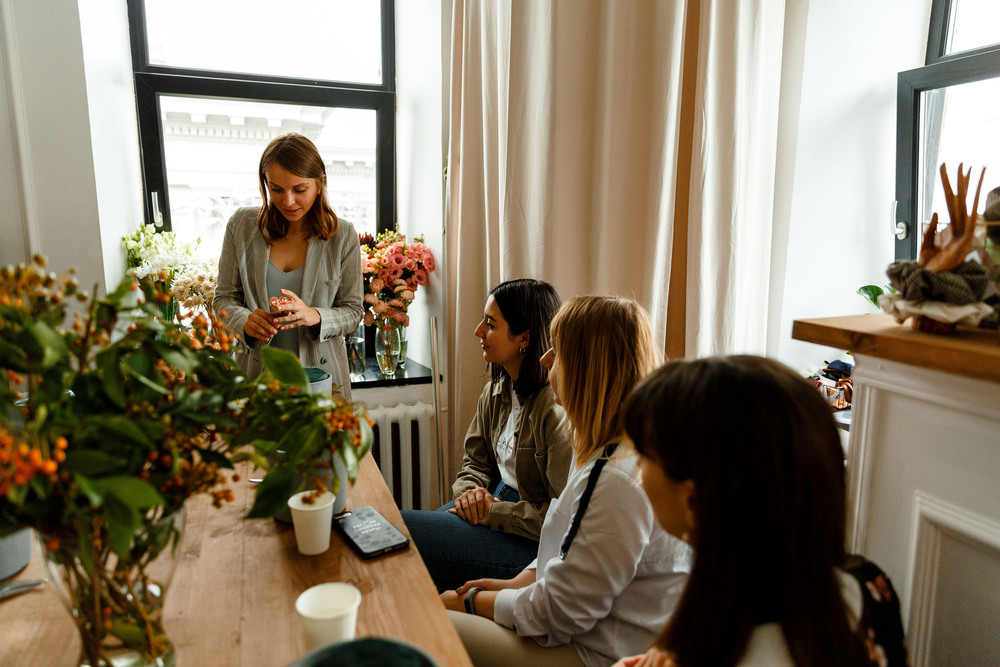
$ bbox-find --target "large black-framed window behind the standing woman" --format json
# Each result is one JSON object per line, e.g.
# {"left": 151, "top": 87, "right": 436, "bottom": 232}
{"left": 128, "top": 0, "right": 396, "bottom": 258}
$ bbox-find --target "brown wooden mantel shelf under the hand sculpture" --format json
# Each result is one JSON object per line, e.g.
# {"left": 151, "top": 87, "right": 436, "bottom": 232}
{"left": 792, "top": 313, "right": 1000, "bottom": 382}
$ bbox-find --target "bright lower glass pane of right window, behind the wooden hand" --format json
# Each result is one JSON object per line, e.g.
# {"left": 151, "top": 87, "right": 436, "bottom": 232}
{"left": 918, "top": 79, "right": 1000, "bottom": 233}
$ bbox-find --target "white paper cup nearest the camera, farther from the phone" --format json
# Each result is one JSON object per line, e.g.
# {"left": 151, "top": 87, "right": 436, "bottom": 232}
{"left": 295, "top": 581, "right": 361, "bottom": 651}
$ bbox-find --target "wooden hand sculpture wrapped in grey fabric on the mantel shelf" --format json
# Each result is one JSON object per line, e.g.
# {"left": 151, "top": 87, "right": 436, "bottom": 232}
{"left": 878, "top": 164, "right": 992, "bottom": 333}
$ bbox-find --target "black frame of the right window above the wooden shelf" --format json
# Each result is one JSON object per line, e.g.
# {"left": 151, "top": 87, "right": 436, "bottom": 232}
{"left": 893, "top": 0, "right": 1000, "bottom": 260}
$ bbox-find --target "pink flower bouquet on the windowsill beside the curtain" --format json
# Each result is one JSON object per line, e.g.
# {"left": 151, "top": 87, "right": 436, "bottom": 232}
{"left": 360, "top": 231, "right": 435, "bottom": 330}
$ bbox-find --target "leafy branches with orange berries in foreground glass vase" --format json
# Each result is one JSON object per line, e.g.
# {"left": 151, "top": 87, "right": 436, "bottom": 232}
{"left": 0, "top": 257, "right": 372, "bottom": 667}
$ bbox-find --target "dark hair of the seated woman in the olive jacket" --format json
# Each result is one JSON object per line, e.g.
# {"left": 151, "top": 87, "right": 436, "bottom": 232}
{"left": 490, "top": 278, "right": 561, "bottom": 398}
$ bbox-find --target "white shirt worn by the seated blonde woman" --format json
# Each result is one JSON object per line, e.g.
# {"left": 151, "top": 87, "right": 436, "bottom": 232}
{"left": 494, "top": 447, "right": 692, "bottom": 667}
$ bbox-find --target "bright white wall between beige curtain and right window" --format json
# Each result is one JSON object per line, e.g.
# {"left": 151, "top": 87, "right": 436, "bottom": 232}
{"left": 768, "top": 0, "right": 930, "bottom": 368}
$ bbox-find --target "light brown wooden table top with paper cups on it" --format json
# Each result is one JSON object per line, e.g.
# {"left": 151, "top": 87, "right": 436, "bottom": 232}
{"left": 0, "top": 455, "right": 471, "bottom": 667}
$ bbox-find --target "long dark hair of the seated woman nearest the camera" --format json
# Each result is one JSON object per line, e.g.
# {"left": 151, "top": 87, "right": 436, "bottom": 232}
{"left": 625, "top": 356, "right": 868, "bottom": 666}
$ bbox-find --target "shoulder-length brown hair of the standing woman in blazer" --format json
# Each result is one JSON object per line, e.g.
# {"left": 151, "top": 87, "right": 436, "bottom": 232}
{"left": 257, "top": 132, "right": 340, "bottom": 246}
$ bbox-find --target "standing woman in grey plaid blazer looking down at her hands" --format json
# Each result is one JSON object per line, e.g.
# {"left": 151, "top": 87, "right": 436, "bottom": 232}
{"left": 212, "top": 132, "right": 363, "bottom": 399}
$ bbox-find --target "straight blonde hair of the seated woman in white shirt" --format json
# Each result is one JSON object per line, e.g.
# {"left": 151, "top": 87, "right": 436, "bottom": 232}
{"left": 552, "top": 296, "right": 663, "bottom": 465}
